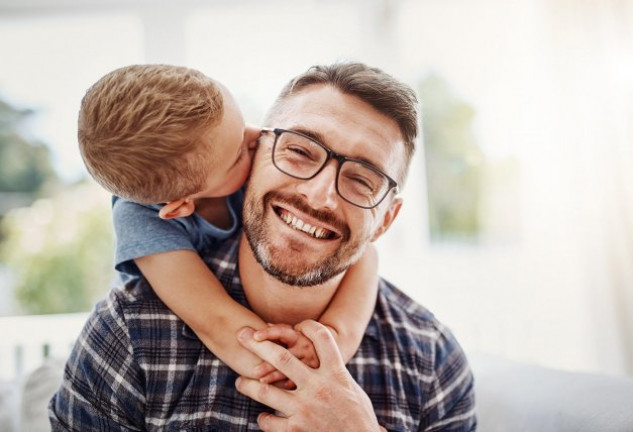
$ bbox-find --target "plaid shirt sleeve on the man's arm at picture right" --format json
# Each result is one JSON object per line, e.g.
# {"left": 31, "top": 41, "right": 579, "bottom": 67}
{"left": 420, "top": 328, "right": 477, "bottom": 432}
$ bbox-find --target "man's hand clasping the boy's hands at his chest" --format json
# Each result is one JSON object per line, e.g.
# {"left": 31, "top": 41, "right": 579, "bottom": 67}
{"left": 236, "top": 320, "right": 384, "bottom": 432}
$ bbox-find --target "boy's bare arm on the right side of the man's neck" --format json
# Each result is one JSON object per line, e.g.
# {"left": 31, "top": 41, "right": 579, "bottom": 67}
{"left": 319, "top": 244, "right": 378, "bottom": 363}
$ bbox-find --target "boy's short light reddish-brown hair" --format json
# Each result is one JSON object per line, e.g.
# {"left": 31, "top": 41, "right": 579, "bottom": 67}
{"left": 78, "top": 65, "right": 223, "bottom": 204}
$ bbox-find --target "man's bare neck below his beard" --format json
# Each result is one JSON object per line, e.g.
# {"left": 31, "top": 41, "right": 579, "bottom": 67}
{"left": 238, "top": 234, "right": 343, "bottom": 325}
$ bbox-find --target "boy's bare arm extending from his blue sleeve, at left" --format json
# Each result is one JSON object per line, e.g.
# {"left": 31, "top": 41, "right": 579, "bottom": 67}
{"left": 134, "top": 250, "right": 274, "bottom": 378}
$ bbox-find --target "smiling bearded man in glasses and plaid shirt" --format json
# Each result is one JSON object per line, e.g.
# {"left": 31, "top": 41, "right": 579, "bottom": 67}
{"left": 51, "top": 64, "right": 475, "bottom": 431}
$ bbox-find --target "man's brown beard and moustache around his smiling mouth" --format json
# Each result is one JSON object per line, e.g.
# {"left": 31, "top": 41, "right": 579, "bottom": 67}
{"left": 244, "top": 191, "right": 364, "bottom": 287}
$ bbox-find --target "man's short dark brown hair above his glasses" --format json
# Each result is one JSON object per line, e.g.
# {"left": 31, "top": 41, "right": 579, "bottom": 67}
{"left": 268, "top": 62, "right": 418, "bottom": 182}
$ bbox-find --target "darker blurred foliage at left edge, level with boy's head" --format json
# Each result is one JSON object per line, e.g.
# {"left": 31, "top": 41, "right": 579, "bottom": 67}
{"left": 0, "top": 100, "right": 56, "bottom": 193}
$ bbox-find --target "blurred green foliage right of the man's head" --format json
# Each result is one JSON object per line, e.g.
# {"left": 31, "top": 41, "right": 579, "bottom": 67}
{"left": 419, "top": 75, "right": 483, "bottom": 241}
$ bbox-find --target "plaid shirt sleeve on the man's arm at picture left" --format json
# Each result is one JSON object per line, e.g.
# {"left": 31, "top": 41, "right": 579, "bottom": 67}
{"left": 49, "top": 291, "right": 145, "bottom": 431}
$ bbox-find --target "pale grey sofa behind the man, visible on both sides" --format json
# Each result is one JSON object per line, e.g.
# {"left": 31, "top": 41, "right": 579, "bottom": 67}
{"left": 0, "top": 353, "right": 633, "bottom": 432}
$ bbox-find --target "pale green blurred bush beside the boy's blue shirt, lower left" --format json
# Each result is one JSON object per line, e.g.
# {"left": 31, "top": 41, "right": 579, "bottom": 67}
{"left": 0, "top": 184, "right": 113, "bottom": 314}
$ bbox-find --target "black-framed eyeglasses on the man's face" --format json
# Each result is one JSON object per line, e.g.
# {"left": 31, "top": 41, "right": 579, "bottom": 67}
{"left": 262, "top": 128, "right": 398, "bottom": 209}
